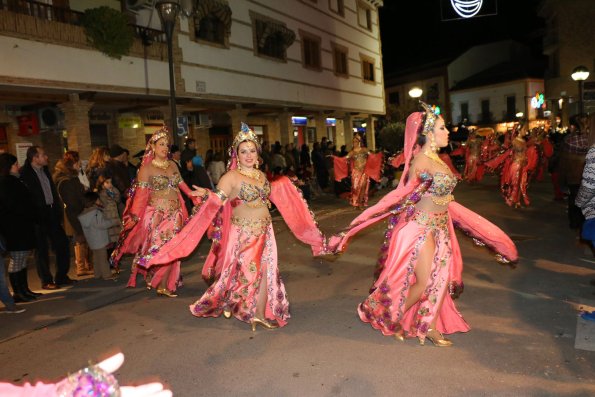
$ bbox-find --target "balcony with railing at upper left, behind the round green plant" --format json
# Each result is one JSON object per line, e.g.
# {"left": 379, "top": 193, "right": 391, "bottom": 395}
{"left": 0, "top": 0, "right": 167, "bottom": 59}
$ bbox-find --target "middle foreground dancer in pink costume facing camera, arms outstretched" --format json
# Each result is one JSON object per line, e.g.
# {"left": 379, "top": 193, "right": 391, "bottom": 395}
{"left": 149, "top": 123, "right": 327, "bottom": 331}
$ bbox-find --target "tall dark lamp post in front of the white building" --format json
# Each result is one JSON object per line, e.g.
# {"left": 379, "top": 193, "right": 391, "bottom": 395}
{"left": 155, "top": 0, "right": 181, "bottom": 142}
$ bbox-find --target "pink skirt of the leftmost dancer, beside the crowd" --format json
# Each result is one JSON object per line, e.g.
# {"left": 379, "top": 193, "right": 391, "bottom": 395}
{"left": 128, "top": 199, "right": 184, "bottom": 292}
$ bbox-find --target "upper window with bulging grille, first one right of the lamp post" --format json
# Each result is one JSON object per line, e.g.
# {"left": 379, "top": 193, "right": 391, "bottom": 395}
{"left": 191, "top": 1, "right": 231, "bottom": 47}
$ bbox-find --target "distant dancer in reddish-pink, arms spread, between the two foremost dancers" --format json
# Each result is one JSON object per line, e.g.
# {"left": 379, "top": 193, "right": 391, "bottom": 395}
{"left": 333, "top": 133, "right": 382, "bottom": 209}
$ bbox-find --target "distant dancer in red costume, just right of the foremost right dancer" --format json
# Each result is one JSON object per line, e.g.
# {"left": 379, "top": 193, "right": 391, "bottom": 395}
{"left": 485, "top": 125, "right": 537, "bottom": 208}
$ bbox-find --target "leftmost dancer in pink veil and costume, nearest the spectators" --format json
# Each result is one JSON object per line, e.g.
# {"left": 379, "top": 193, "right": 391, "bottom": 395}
{"left": 111, "top": 127, "right": 199, "bottom": 298}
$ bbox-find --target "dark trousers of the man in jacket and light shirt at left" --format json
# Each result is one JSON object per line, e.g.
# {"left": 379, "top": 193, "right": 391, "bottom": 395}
{"left": 35, "top": 206, "right": 70, "bottom": 285}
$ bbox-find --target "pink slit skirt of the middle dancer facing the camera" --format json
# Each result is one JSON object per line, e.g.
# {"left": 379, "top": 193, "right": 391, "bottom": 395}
{"left": 190, "top": 218, "right": 290, "bottom": 326}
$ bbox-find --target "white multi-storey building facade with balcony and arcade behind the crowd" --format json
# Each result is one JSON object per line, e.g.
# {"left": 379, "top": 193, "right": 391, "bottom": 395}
{"left": 0, "top": 0, "right": 385, "bottom": 162}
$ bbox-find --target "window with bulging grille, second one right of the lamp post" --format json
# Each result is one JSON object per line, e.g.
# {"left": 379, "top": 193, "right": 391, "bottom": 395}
{"left": 252, "top": 13, "right": 296, "bottom": 61}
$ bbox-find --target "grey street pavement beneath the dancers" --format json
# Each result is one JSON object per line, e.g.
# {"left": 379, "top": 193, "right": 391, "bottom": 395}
{"left": 0, "top": 177, "right": 595, "bottom": 396}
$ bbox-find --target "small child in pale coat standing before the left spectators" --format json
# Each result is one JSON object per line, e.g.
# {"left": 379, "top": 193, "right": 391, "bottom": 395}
{"left": 78, "top": 192, "right": 120, "bottom": 280}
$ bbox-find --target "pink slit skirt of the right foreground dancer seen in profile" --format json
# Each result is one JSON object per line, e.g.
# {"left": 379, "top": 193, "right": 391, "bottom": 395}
{"left": 358, "top": 210, "right": 469, "bottom": 339}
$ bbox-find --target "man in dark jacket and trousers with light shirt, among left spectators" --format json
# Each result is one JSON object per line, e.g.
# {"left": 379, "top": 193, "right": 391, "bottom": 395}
{"left": 20, "top": 146, "right": 73, "bottom": 289}
